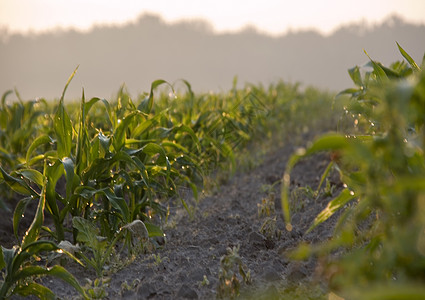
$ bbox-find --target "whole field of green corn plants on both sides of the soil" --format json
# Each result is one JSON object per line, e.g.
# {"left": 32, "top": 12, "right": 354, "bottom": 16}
{"left": 0, "top": 45, "right": 425, "bottom": 299}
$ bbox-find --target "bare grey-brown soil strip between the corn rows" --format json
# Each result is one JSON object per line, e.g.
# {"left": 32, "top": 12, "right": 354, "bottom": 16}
{"left": 0, "top": 135, "right": 340, "bottom": 299}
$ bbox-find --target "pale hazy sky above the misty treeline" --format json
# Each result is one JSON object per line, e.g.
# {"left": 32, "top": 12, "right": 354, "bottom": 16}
{"left": 0, "top": 0, "right": 425, "bottom": 34}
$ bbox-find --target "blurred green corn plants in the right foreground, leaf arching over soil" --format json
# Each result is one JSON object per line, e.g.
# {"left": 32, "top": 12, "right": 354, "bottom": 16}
{"left": 282, "top": 45, "right": 425, "bottom": 297}
